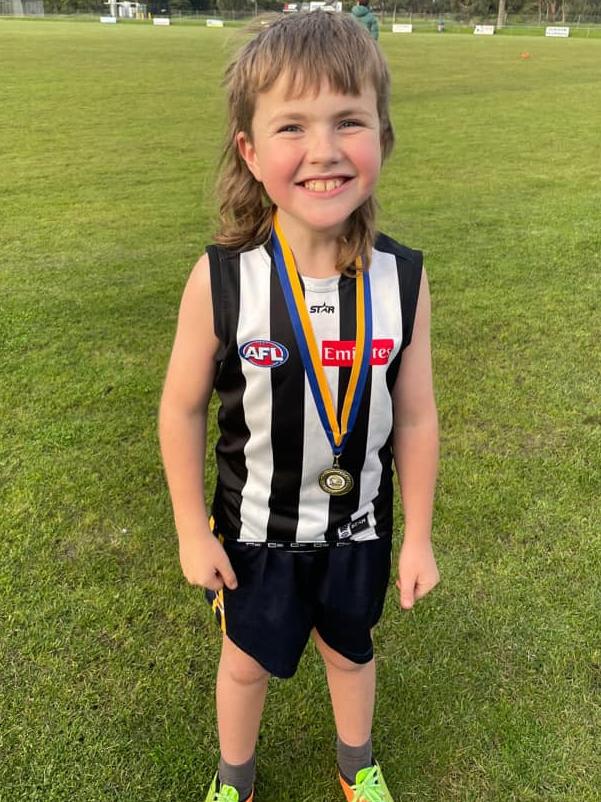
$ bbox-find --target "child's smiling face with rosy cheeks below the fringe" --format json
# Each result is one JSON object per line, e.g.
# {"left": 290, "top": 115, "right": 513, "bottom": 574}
{"left": 238, "top": 76, "right": 382, "bottom": 242}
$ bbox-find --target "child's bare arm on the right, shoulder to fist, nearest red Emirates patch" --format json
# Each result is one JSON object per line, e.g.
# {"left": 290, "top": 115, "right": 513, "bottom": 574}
{"left": 393, "top": 271, "right": 439, "bottom": 609}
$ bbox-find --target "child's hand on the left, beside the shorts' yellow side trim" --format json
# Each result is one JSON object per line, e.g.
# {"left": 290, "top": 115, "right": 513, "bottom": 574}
{"left": 179, "top": 534, "right": 238, "bottom": 590}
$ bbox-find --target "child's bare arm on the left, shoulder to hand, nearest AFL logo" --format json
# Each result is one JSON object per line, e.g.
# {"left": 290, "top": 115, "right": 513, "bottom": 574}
{"left": 159, "top": 255, "right": 236, "bottom": 590}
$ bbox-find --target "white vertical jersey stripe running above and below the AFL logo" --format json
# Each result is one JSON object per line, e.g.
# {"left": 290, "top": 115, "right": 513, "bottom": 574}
{"left": 237, "top": 249, "right": 277, "bottom": 541}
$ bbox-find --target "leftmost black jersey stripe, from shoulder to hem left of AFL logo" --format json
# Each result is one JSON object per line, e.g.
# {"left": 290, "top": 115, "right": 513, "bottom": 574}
{"left": 209, "top": 247, "right": 250, "bottom": 538}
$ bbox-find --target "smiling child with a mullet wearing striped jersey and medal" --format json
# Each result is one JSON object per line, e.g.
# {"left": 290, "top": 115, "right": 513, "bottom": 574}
{"left": 160, "top": 12, "right": 438, "bottom": 802}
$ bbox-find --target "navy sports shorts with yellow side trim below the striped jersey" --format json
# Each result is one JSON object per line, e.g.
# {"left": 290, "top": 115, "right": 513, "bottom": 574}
{"left": 207, "top": 537, "right": 392, "bottom": 678}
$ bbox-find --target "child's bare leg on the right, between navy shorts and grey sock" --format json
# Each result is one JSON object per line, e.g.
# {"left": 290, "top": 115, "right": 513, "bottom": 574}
{"left": 313, "top": 630, "right": 376, "bottom": 746}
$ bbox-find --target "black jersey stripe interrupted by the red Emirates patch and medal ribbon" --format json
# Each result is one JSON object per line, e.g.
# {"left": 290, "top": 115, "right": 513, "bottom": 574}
{"left": 326, "top": 276, "right": 371, "bottom": 538}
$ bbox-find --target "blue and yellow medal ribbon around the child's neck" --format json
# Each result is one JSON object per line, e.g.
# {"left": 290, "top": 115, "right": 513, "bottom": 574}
{"left": 271, "top": 213, "right": 372, "bottom": 457}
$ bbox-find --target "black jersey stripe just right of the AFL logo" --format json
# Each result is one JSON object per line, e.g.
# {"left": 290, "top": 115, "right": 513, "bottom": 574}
{"left": 267, "top": 260, "right": 305, "bottom": 542}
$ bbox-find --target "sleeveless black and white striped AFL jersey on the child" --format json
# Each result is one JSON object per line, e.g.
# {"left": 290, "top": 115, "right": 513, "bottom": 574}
{"left": 207, "top": 234, "right": 422, "bottom": 548}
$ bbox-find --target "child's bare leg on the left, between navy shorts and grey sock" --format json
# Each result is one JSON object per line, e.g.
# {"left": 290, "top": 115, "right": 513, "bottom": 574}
{"left": 217, "top": 635, "right": 269, "bottom": 765}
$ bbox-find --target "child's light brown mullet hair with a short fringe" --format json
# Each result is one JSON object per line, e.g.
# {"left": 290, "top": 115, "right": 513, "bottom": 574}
{"left": 216, "top": 11, "right": 394, "bottom": 272}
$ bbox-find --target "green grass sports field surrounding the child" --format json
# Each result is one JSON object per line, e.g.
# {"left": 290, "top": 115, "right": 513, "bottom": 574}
{"left": 0, "top": 20, "right": 601, "bottom": 802}
